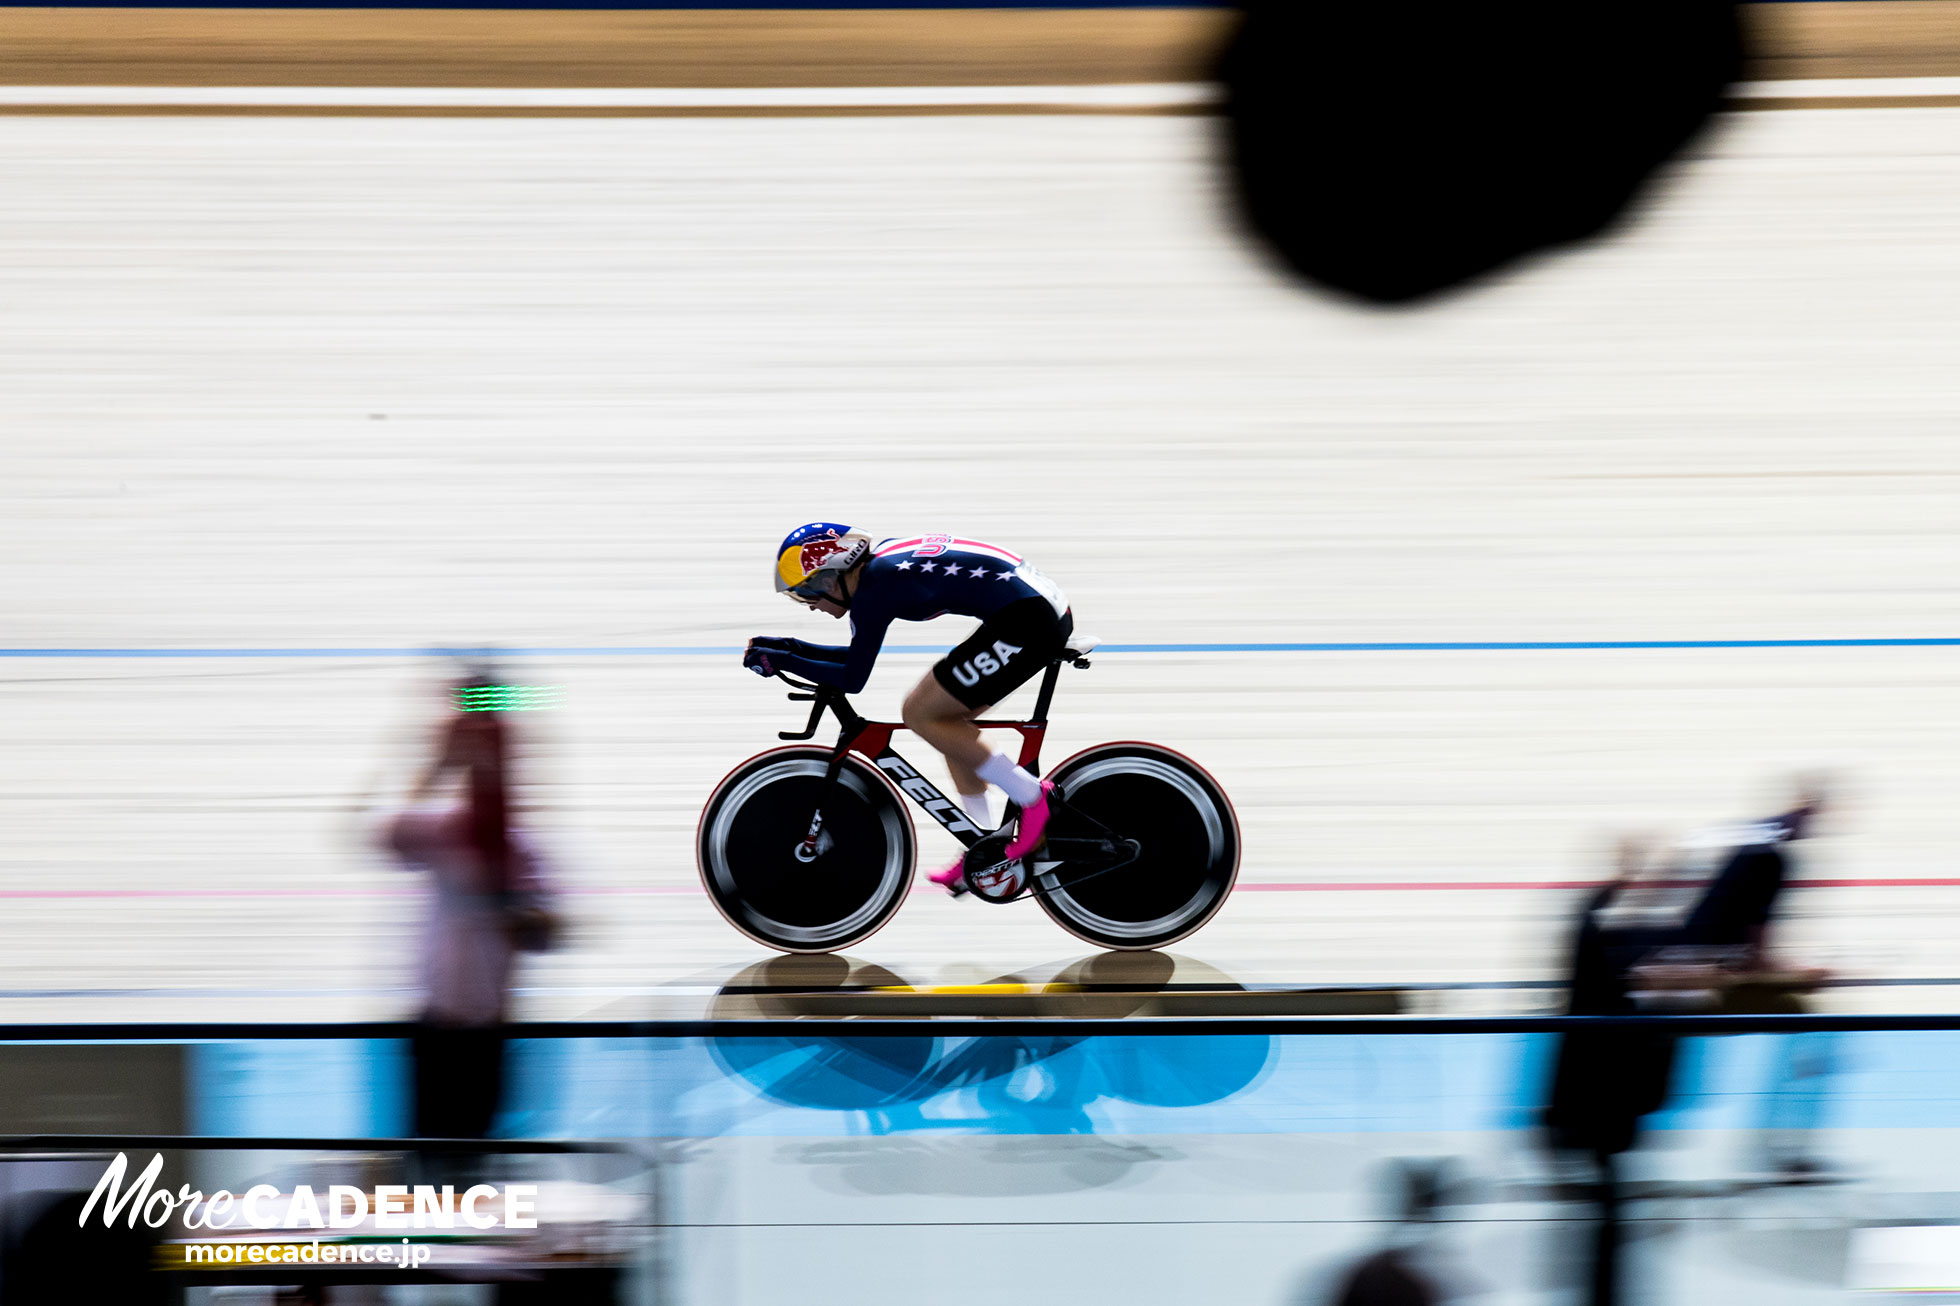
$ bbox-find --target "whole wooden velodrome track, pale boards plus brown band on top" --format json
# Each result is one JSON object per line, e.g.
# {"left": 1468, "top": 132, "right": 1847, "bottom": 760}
{"left": 0, "top": 4, "right": 1960, "bottom": 1020}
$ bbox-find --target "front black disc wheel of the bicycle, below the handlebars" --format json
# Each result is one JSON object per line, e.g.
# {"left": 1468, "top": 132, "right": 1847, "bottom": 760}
{"left": 696, "top": 747, "right": 911, "bottom": 953}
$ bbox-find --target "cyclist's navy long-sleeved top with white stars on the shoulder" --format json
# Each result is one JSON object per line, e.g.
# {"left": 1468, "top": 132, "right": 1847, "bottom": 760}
{"left": 768, "top": 535, "right": 1068, "bottom": 694}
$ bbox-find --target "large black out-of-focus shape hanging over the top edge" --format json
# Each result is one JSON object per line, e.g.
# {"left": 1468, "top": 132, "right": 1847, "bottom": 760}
{"left": 1219, "top": 0, "right": 1742, "bottom": 304}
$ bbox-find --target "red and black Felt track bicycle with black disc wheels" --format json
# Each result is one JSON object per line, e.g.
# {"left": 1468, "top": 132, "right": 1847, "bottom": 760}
{"left": 696, "top": 637, "right": 1239, "bottom": 953}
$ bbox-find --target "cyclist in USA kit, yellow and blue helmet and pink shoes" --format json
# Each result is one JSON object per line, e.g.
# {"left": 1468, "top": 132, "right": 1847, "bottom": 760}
{"left": 743, "top": 522, "right": 1074, "bottom": 892}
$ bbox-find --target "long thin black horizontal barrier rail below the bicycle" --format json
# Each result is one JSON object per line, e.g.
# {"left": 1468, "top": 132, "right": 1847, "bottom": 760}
{"left": 0, "top": 1012, "right": 1960, "bottom": 1045}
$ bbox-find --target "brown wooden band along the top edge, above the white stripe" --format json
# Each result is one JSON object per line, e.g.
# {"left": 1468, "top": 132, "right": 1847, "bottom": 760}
{"left": 0, "top": 0, "right": 1960, "bottom": 98}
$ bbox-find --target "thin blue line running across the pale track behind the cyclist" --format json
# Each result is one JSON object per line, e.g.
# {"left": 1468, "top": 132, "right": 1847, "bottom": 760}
{"left": 0, "top": 635, "right": 1960, "bottom": 659}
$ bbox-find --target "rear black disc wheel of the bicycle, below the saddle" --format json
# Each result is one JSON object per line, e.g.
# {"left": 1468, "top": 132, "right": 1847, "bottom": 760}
{"left": 1037, "top": 743, "right": 1239, "bottom": 949}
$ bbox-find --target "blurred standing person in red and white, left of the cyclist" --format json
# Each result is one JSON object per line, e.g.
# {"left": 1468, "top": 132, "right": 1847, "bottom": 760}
{"left": 382, "top": 654, "right": 555, "bottom": 1137}
